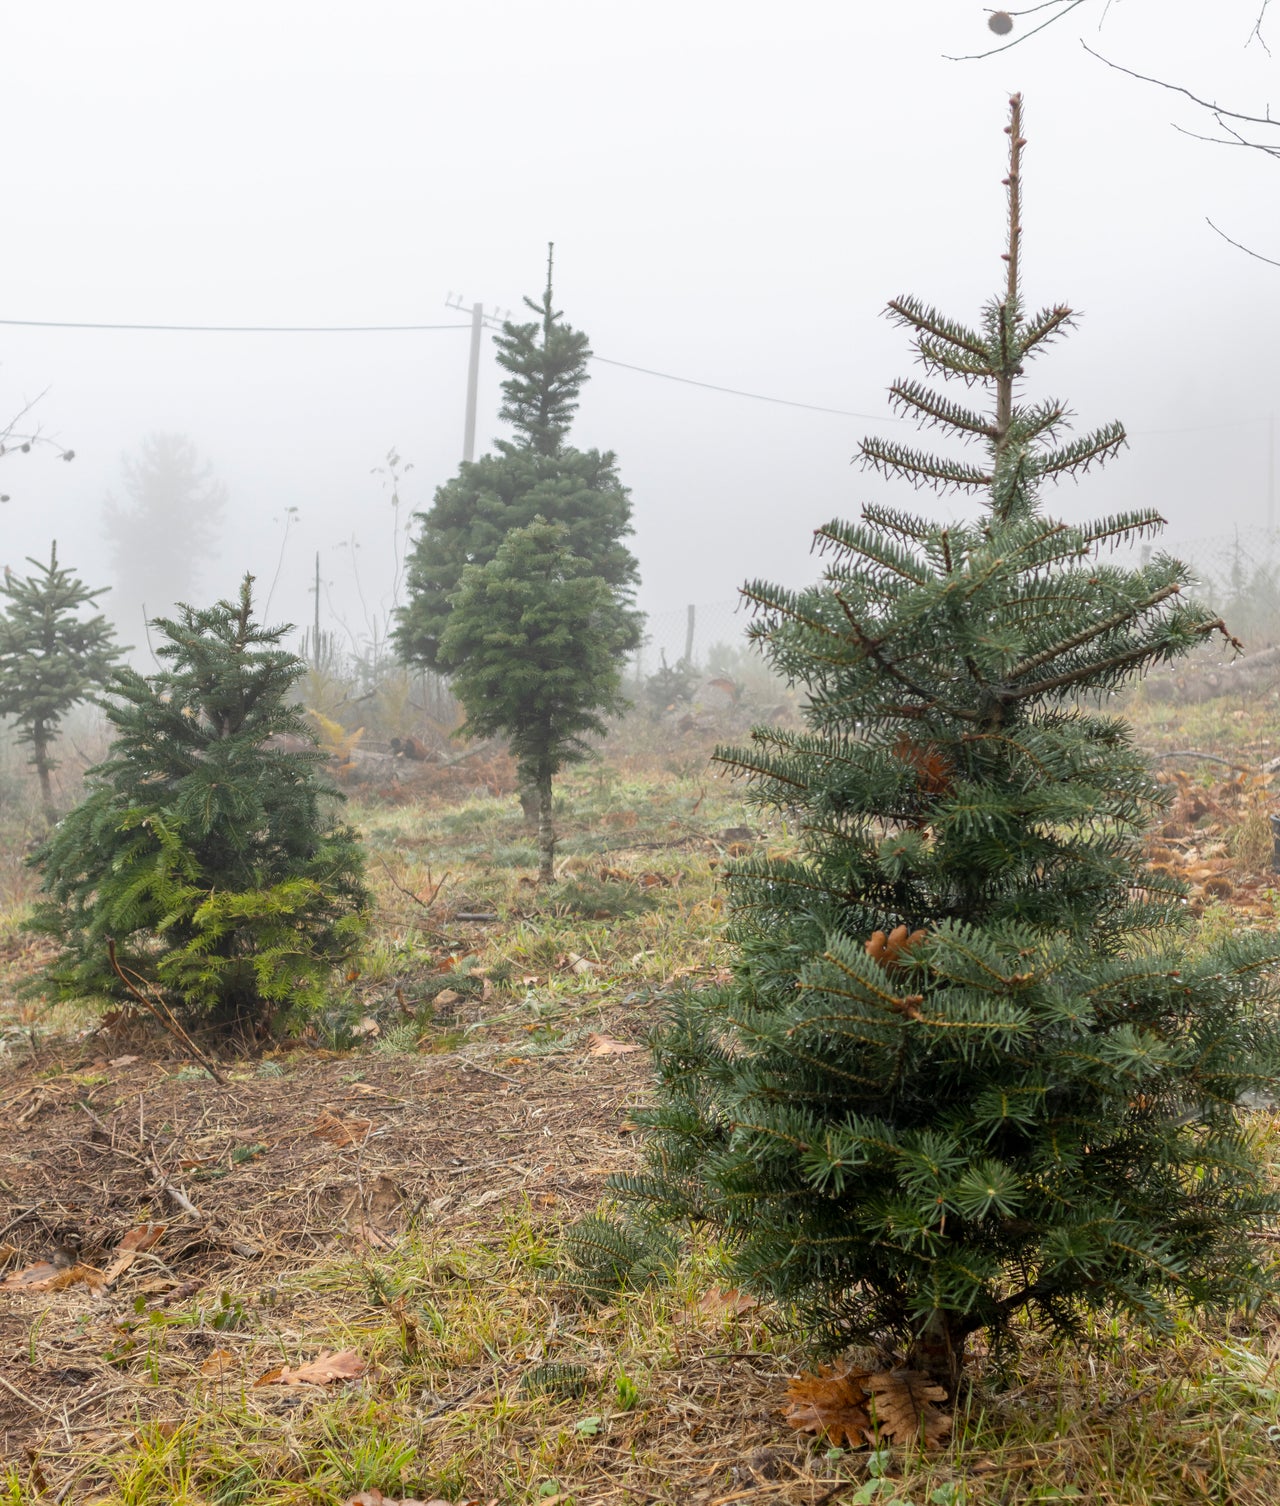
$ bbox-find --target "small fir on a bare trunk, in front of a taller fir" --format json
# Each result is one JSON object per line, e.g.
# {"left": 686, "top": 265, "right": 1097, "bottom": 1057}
{"left": 440, "top": 518, "right": 635, "bottom": 883}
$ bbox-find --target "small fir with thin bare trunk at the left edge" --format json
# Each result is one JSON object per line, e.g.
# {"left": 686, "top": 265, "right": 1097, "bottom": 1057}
{"left": 0, "top": 542, "right": 123, "bottom": 824}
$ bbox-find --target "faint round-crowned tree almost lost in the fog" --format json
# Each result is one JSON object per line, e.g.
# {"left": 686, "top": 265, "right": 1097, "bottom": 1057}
{"left": 102, "top": 434, "right": 226, "bottom": 633}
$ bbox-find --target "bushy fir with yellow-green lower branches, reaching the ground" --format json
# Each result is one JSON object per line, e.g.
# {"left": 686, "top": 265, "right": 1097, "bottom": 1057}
{"left": 32, "top": 575, "right": 369, "bottom": 1029}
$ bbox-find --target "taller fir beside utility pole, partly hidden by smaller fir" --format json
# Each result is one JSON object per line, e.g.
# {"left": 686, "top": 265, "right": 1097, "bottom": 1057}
{"left": 395, "top": 256, "right": 640, "bottom": 673}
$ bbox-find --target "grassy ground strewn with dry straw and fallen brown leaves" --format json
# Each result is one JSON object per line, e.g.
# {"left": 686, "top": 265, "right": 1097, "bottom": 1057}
{"left": 0, "top": 734, "right": 1280, "bottom": 1506}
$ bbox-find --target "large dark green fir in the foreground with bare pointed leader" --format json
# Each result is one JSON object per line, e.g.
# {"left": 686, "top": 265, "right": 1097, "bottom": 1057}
{"left": 617, "top": 96, "right": 1280, "bottom": 1390}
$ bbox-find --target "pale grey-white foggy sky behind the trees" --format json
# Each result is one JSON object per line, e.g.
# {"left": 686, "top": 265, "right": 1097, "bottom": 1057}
{"left": 0, "top": 0, "right": 1280, "bottom": 656}
